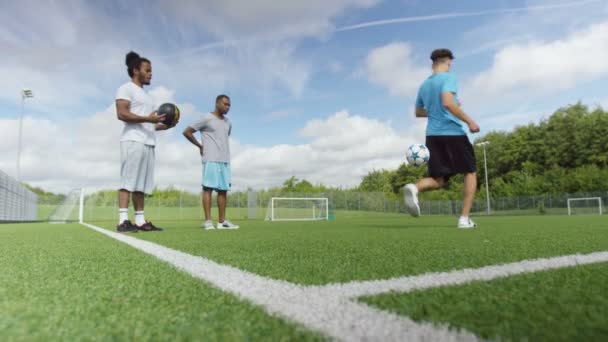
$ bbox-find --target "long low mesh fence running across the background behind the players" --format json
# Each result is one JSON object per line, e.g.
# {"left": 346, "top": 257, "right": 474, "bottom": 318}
{"left": 50, "top": 190, "right": 608, "bottom": 221}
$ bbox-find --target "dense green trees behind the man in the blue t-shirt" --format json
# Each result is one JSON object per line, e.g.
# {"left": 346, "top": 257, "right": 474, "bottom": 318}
{"left": 359, "top": 103, "right": 608, "bottom": 199}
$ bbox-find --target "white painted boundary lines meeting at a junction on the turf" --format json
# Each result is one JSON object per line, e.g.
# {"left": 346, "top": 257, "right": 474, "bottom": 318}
{"left": 83, "top": 223, "right": 608, "bottom": 341}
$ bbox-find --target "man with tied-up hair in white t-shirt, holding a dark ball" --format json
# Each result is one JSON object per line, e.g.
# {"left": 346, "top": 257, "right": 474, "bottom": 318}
{"left": 116, "top": 51, "right": 167, "bottom": 233}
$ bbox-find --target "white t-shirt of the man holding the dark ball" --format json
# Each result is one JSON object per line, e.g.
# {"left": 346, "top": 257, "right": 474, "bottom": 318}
{"left": 116, "top": 82, "right": 156, "bottom": 146}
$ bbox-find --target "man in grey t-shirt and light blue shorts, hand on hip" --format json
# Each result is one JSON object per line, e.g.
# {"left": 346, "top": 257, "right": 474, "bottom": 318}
{"left": 184, "top": 95, "right": 239, "bottom": 230}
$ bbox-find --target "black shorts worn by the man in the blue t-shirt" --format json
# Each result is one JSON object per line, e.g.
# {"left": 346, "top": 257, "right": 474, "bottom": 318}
{"left": 426, "top": 135, "right": 477, "bottom": 181}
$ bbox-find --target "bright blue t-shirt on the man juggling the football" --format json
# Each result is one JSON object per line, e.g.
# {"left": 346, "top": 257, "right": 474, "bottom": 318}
{"left": 416, "top": 72, "right": 466, "bottom": 136}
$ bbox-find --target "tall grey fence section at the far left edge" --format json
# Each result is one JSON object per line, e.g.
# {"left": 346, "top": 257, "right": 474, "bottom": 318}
{"left": 0, "top": 171, "right": 38, "bottom": 222}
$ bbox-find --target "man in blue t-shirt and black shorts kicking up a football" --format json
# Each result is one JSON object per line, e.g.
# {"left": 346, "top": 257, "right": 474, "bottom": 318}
{"left": 404, "top": 49, "right": 479, "bottom": 228}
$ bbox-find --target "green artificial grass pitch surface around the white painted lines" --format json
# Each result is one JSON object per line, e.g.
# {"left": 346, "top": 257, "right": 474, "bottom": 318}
{"left": 0, "top": 212, "right": 608, "bottom": 341}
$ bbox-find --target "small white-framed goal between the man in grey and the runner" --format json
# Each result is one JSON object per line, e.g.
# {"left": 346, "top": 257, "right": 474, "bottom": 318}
{"left": 266, "top": 197, "right": 329, "bottom": 221}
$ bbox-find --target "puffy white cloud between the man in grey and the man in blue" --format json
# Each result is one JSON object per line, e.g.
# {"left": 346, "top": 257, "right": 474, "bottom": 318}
{"left": 232, "top": 111, "right": 424, "bottom": 188}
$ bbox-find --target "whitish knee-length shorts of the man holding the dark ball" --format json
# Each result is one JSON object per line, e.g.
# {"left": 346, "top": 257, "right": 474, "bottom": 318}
{"left": 120, "top": 141, "right": 154, "bottom": 195}
